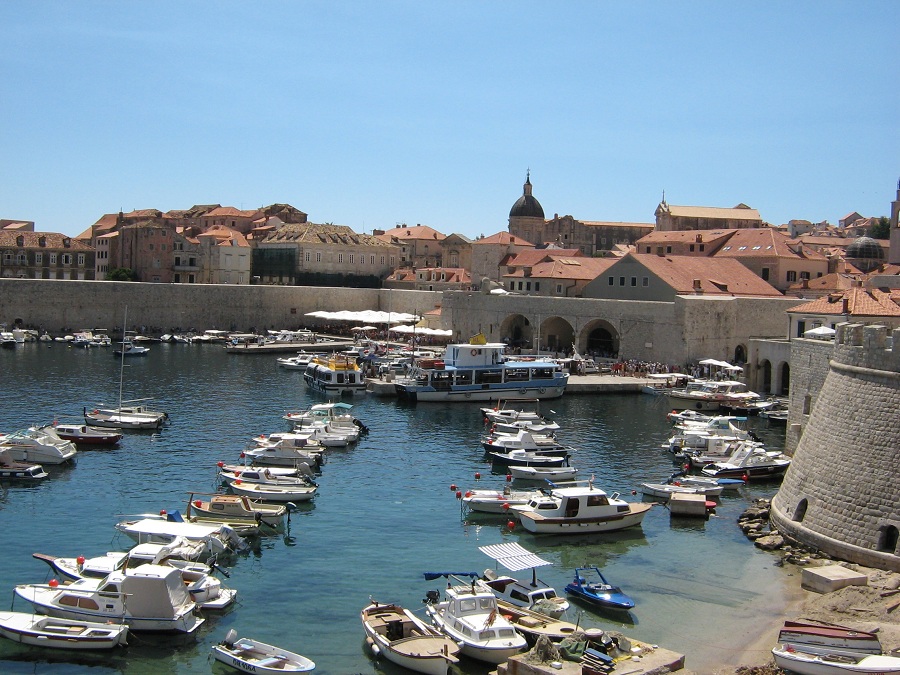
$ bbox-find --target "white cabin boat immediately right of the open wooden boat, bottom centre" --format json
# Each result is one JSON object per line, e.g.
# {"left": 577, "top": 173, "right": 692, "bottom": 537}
{"left": 425, "top": 582, "right": 528, "bottom": 664}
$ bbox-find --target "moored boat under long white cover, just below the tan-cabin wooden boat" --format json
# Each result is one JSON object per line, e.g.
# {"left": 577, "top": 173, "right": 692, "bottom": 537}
{"left": 116, "top": 512, "right": 248, "bottom": 556}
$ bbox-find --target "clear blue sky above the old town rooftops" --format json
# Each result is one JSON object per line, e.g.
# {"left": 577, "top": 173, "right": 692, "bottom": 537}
{"left": 0, "top": 0, "right": 900, "bottom": 237}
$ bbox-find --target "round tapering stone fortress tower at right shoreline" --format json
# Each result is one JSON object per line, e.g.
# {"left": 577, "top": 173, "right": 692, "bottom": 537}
{"left": 770, "top": 324, "right": 900, "bottom": 571}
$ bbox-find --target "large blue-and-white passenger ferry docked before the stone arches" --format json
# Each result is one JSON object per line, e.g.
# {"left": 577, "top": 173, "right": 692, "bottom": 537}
{"left": 394, "top": 336, "right": 569, "bottom": 401}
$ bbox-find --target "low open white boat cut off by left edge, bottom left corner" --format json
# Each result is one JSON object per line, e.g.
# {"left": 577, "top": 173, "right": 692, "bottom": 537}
{"left": 0, "top": 612, "right": 128, "bottom": 649}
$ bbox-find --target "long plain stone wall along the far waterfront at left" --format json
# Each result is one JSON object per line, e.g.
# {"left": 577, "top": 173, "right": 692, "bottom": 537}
{"left": 0, "top": 279, "right": 441, "bottom": 335}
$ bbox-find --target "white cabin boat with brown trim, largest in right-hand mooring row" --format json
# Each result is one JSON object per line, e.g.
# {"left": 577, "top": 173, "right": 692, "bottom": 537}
{"left": 510, "top": 481, "right": 653, "bottom": 534}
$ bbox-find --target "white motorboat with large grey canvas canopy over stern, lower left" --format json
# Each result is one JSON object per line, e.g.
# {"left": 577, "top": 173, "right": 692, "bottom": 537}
{"left": 15, "top": 565, "right": 204, "bottom": 633}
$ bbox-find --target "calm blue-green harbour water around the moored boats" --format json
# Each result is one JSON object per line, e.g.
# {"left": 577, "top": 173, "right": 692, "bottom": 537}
{"left": 0, "top": 343, "right": 786, "bottom": 675}
